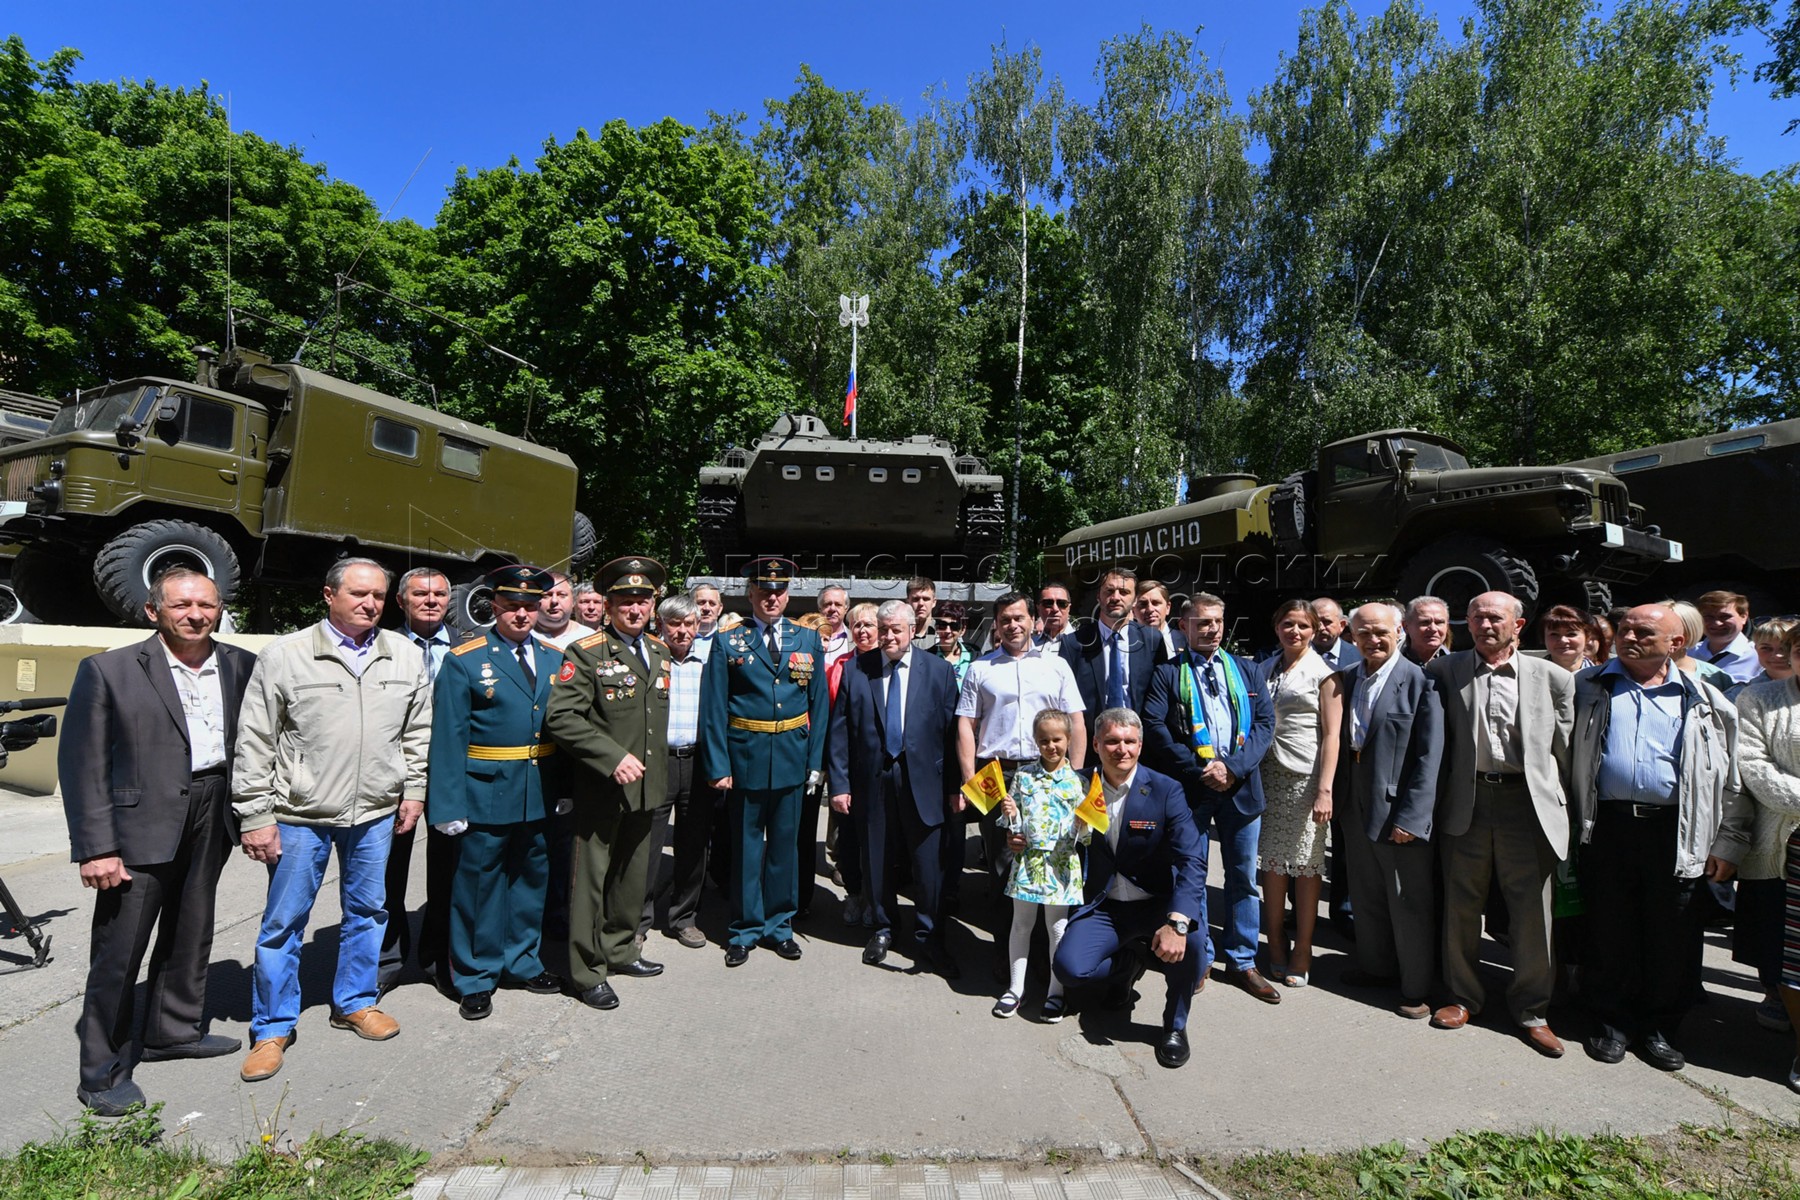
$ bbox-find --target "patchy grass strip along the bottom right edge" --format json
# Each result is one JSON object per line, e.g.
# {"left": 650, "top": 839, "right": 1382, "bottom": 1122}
{"left": 1195, "top": 1123, "right": 1800, "bottom": 1200}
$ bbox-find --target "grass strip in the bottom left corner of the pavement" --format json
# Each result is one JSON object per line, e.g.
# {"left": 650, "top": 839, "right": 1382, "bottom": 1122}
{"left": 0, "top": 1105, "right": 430, "bottom": 1200}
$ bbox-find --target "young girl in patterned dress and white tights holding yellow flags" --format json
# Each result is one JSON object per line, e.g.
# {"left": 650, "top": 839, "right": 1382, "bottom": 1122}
{"left": 994, "top": 709, "right": 1093, "bottom": 1024}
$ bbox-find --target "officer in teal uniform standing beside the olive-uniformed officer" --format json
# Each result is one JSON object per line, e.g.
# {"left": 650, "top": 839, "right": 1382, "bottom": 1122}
{"left": 427, "top": 565, "right": 567, "bottom": 1020}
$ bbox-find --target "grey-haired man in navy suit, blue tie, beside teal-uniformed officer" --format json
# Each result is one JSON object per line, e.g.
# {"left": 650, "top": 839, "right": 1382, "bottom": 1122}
{"left": 828, "top": 601, "right": 963, "bottom": 979}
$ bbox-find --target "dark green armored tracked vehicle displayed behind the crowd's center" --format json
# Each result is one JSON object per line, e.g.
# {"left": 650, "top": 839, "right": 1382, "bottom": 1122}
{"left": 698, "top": 414, "right": 1006, "bottom": 579}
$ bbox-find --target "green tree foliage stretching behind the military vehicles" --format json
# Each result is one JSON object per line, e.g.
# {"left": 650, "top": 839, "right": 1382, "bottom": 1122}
{"left": 0, "top": 0, "right": 1800, "bottom": 572}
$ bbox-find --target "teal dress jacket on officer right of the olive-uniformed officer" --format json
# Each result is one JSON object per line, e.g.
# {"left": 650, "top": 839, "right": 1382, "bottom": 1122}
{"left": 700, "top": 617, "right": 832, "bottom": 792}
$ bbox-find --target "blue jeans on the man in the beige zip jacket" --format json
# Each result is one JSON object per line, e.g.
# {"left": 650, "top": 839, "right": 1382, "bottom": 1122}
{"left": 250, "top": 813, "right": 394, "bottom": 1042}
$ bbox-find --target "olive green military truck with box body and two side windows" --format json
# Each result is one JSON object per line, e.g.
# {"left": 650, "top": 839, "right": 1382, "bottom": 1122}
{"left": 0, "top": 349, "right": 594, "bottom": 624}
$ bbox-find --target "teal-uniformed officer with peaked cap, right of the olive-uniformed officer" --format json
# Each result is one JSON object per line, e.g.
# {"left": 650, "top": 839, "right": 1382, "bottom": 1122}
{"left": 697, "top": 558, "right": 830, "bottom": 966}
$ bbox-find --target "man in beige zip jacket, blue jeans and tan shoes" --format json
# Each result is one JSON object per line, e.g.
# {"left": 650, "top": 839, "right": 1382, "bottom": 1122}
{"left": 232, "top": 558, "right": 432, "bottom": 1081}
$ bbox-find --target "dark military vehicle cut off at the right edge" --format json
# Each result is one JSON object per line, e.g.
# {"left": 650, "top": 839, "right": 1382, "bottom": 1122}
{"left": 1568, "top": 419, "right": 1800, "bottom": 613}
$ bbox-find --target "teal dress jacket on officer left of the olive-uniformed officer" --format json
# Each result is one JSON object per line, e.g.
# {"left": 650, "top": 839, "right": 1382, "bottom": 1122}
{"left": 427, "top": 630, "right": 567, "bottom": 826}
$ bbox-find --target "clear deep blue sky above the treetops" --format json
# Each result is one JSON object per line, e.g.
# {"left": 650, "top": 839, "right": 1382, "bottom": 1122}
{"left": 9, "top": 0, "right": 1800, "bottom": 223}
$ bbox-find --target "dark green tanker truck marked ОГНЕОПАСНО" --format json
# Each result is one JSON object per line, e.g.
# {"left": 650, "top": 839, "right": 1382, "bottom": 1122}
{"left": 1046, "top": 430, "right": 1681, "bottom": 635}
